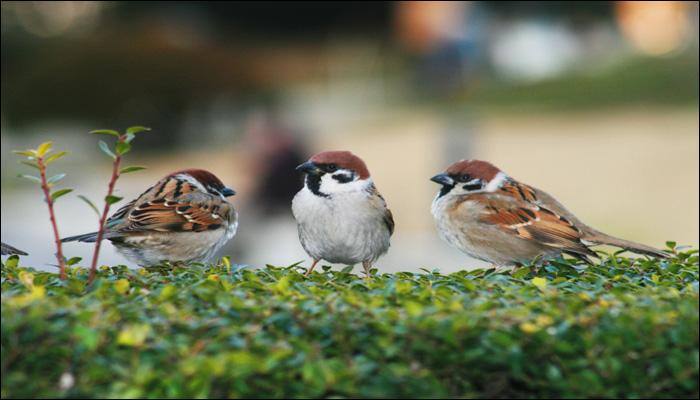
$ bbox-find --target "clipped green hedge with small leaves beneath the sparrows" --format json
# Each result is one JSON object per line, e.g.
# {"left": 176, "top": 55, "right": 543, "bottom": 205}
{"left": 2, "top": 251, "right": 699, "bottom": 398}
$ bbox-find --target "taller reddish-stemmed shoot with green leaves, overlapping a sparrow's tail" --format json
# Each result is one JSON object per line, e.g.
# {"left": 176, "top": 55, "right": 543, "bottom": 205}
{"left": 79, "top": 126, "right": 151, "bottom": 282}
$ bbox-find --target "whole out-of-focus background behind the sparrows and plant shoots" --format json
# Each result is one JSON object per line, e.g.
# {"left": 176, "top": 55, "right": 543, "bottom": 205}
{"left": 0, "top": 1, "right": 699, "bottom": 272}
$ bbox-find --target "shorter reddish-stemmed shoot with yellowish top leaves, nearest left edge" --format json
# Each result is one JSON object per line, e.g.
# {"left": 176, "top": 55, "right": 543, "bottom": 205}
{"left": 14, "top": 142, "right": 73, "bottom": 279}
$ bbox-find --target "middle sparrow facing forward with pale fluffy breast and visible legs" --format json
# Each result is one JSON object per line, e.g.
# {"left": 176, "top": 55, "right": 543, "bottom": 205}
{"left": 292, "top": 151, "right": 394, "bottom": 276}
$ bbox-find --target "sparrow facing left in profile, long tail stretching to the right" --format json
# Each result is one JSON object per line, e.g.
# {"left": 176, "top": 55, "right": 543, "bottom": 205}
{"left": 431, "top": 160, "right": 668, "bottom": 266}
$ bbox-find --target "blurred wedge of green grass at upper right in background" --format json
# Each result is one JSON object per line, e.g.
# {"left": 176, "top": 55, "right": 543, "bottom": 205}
{"left": 458, "top": 53, "right": 699, "bottom": 112}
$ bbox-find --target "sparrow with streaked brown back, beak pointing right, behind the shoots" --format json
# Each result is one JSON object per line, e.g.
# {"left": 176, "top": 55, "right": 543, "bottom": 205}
{"left": 62, "top": 169, "right": 238, "bottom": 266}
